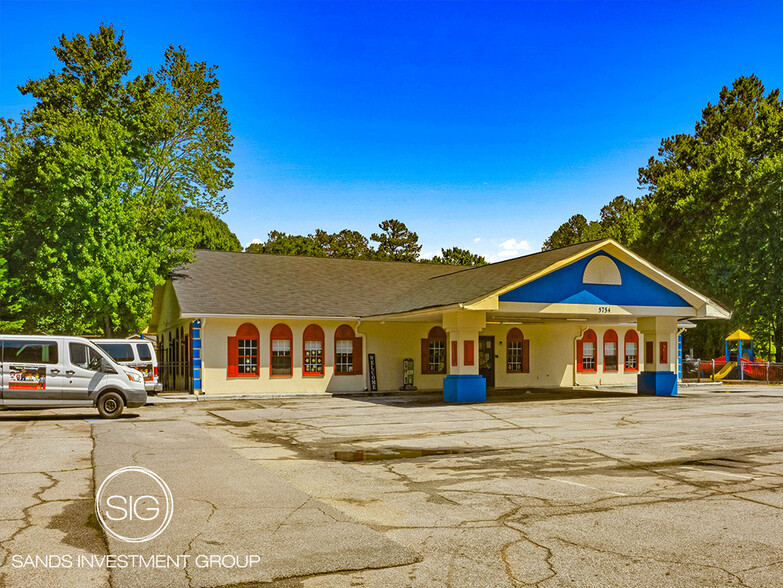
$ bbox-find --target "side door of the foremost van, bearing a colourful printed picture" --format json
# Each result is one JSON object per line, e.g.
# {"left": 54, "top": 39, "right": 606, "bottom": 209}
{"left": 0, "top": 337, "right": 63, "bottom": 407}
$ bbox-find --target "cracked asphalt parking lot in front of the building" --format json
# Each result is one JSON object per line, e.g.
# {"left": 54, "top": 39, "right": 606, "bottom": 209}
{"left": 0, "top": 386, "right": 783, "bottom": 587}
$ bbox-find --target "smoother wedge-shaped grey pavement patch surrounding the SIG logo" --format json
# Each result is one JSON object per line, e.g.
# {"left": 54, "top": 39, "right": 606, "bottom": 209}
{"left": 92, "top": 420, "right": 418, "bottom": 588}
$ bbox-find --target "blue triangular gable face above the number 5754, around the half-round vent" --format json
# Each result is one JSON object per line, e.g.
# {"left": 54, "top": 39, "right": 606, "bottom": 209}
{"left": 500, "top": 252, "right": 690, "bottom": 307}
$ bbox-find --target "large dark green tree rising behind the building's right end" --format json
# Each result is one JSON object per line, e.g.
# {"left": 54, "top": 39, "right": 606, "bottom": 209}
{"left": 637, "top": 76, "right": 783, "bottom": 361}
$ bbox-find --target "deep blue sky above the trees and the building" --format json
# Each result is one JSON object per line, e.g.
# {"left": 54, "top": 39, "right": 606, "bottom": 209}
{"left": 0, "top": 0, "right": 783, "bottom": 259}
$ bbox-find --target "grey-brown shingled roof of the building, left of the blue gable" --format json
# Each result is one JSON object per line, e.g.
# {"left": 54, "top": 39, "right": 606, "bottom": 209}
{"left": 170, "top": 241, "right": 596, "bottom": 318}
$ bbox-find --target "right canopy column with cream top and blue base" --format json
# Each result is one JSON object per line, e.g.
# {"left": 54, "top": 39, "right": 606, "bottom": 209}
{"left": 637, "top": 317, "right": 678, "bottom": 396}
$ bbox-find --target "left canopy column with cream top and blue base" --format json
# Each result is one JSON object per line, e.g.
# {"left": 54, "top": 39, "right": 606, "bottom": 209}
{"left": 443, "top": 310, "right": 487, "bottom": 402}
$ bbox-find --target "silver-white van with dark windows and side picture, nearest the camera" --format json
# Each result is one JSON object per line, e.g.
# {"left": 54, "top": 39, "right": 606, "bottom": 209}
{"left": 0, "top": 335, "right": 147, "bottom": 419}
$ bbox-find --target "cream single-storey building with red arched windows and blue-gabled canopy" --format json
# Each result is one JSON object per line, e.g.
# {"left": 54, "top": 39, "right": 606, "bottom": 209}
{"left": 150, "top": 239, "right": 730, "bottom": 401}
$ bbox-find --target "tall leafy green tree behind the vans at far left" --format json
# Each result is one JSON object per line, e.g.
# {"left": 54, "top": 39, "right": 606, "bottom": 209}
{"left": 0, "top": 26, "right": 233, "bottom": 336}
